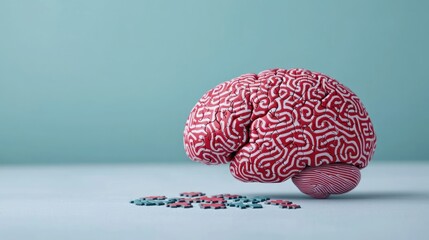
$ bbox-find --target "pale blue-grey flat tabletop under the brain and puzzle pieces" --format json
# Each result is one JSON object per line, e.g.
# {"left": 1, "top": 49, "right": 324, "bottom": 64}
{"left": 0, "top": 161, "right": 429, "bottom": 240}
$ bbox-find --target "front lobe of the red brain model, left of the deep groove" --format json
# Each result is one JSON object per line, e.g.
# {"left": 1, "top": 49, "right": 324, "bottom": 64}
{"left": 184, "top": 74, "right": 257, "bottom": 164}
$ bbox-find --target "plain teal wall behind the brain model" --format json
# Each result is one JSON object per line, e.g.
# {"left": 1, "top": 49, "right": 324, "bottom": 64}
{"left": 0, "top": 0, "right": 429, "bottom": 164}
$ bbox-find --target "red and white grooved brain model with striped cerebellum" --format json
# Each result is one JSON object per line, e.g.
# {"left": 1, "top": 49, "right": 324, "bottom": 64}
{"left": 184, "top": 69, "right": 376, "bottom": 198}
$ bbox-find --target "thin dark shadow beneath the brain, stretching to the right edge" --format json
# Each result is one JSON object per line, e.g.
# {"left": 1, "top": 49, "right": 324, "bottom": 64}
{"left": 245, "top": 191, "right": 429, "bottom": 202}
